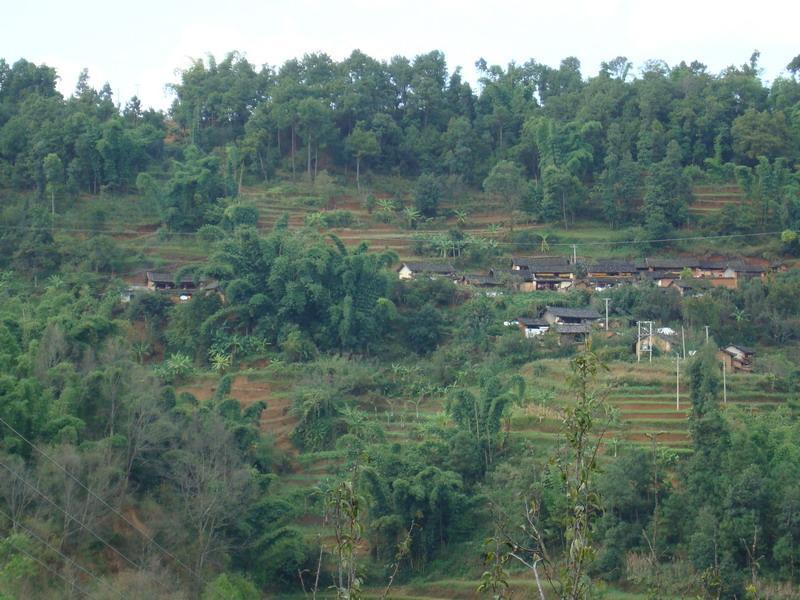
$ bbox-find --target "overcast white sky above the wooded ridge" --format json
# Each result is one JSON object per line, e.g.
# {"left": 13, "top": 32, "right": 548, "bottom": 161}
{"left": 6, "top": 0, "right": 800, "bottom": 108}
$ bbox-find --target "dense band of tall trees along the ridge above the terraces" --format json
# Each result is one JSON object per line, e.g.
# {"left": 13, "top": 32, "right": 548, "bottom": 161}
{"left": 0, "top": 51, "right": 800, "bottom": 235}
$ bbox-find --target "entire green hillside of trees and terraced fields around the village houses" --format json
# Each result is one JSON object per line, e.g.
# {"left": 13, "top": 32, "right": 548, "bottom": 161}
{"left": 0, "top": 51, "right": 800, "bottom": 599}
